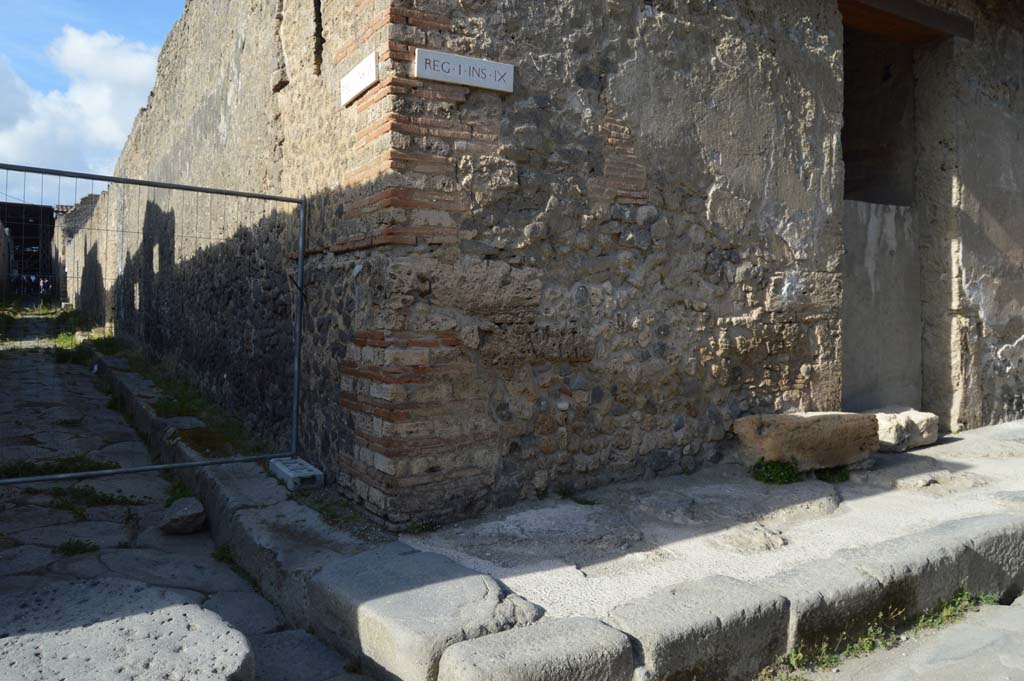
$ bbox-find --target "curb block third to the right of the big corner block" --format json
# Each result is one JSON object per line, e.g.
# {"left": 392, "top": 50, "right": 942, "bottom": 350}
{"left": 758, "top": 560, "right": 887, "bottom": 650}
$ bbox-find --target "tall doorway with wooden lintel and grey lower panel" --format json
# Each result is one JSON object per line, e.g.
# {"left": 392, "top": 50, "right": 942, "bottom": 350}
{"left": 839, "top": 0, "right": 973, "bottom": 412}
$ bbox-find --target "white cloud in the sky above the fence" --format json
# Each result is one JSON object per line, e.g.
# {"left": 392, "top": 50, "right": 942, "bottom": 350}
{"left": 0, "top": 27, "right": 159, "bottom": 173}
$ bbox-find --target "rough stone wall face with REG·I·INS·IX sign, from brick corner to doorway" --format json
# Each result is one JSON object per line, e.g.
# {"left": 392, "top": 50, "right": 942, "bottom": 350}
{"left": 312, "top": 1, "right": 843, "bottom": 522}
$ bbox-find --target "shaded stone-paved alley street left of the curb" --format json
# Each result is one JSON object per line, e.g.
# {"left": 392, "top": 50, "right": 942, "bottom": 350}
{"left": 0, "top": 316, "right": 354, "bottom": 681}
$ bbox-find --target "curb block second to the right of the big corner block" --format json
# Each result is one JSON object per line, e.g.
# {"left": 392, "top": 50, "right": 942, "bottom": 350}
{"left": 608, "top": 577, "right": 790, "bottom": 681}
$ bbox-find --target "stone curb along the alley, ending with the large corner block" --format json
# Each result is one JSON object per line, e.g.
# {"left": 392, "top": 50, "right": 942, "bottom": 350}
{"left": 93, "top": 353, "right": 543, "bottom": 681}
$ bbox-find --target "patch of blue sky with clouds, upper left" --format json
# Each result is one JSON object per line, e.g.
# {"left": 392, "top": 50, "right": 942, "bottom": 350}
{"left": 0, "top": 0, "right": 184, "bottom": 173}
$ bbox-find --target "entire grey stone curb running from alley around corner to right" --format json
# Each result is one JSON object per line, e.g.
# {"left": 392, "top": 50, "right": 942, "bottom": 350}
{"left": 86, "top": 354, "right": 1024, "bottom": 681}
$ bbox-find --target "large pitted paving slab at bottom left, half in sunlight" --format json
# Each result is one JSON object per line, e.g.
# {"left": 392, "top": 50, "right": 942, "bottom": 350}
{"left": 0, "top": 580, "right": 255, "bottom": 681}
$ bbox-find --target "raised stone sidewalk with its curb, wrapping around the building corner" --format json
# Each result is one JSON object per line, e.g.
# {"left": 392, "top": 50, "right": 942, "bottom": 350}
{"left": 98, "top": 348, "right": 1024, "bottom": 681}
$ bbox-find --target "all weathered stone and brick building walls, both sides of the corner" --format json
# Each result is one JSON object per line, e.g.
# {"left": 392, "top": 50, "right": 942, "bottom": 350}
{"left": 56, "top": 0, "right": 1024, "bottom": 525}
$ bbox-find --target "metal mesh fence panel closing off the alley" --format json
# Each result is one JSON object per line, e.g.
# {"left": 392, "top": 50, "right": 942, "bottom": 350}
{"left": 0, "top": 163, "right": 307, "bottom": 484}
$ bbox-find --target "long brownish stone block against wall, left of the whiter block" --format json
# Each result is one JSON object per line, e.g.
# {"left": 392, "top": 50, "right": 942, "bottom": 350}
{"left": 733, "top": 412, "right": 879, "bottom": 470}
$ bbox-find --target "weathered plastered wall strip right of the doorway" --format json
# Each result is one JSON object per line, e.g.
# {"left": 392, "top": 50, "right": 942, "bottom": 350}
{"left": 913, "top": 0, "right": 1024, "bottom": 430}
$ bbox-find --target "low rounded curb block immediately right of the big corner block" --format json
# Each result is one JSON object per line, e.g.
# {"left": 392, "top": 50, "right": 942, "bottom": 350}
{"left": 437, "top": 618, "right": 634, "bottom": 681}
